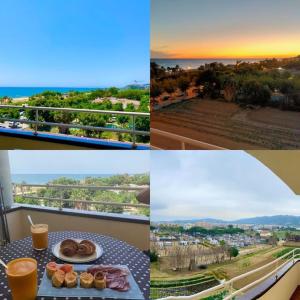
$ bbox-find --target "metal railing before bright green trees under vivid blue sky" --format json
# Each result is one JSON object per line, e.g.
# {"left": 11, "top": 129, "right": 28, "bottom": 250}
{"left": 0, "top": 105, "right": 150, "bottom": 145}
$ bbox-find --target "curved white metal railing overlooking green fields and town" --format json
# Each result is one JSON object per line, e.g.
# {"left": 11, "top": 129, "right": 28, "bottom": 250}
{"left": 158, "top": 248, "right": 300, "bottom": 300}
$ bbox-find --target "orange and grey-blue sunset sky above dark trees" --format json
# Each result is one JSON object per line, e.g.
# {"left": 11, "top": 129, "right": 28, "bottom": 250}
{"left": 151, "top": 0, "right": 300, "bottom": 59}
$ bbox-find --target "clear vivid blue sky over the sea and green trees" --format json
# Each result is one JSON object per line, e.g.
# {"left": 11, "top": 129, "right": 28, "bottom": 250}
{"left": 0, "top": 0, "right": 150, "bottom": 87}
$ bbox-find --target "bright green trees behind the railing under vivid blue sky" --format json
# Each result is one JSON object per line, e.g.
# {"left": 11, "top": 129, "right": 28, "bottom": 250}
{"left": 0, "top": 87, "right": 150, "bottom": 143}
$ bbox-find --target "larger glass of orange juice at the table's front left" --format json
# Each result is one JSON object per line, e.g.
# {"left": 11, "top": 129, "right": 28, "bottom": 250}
{"left": 6, "top": 258, "right": 37, "bottom": 300}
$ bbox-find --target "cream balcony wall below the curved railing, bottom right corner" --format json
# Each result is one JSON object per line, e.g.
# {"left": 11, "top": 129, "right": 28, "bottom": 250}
{"left": 259, "top": 262, "right": 300, "bottom": 300}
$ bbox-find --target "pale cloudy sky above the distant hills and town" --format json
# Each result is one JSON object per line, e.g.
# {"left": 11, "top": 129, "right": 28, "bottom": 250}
{"left": 151, "top": 151, "right": 300, "bottom": 221}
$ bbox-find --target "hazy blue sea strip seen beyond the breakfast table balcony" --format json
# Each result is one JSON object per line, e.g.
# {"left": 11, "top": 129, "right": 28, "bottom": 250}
{"left": 11, "top": 174, "right": 115, "bottom": 184}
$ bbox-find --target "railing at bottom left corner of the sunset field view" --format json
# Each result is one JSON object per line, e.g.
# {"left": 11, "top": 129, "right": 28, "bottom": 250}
{"left": 150, "top": 128, "right": 226, "bottom": 150}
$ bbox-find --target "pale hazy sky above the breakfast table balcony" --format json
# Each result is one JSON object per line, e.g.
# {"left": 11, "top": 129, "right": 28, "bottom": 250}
{"left": 9, "top": 150, "right": 150, "bottom": 174}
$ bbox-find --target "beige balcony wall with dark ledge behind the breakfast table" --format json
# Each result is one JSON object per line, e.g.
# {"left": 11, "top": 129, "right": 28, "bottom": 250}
{"left": 7, "top": 207, "right": 150, "bottom": 251}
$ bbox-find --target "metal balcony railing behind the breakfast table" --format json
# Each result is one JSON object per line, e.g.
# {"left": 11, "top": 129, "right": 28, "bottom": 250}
{"left": 13, "top": 183, "right": 149, "bottom": 210}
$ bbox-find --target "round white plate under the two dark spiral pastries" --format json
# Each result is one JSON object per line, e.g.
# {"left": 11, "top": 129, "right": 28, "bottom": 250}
{"left": 52, "top": 239, "right": 103, "bottom": 264}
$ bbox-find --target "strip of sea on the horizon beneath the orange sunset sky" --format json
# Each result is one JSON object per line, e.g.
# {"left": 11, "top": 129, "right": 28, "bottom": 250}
{"left": 151, "top": 58, "right": 259, "bottom": 70}
